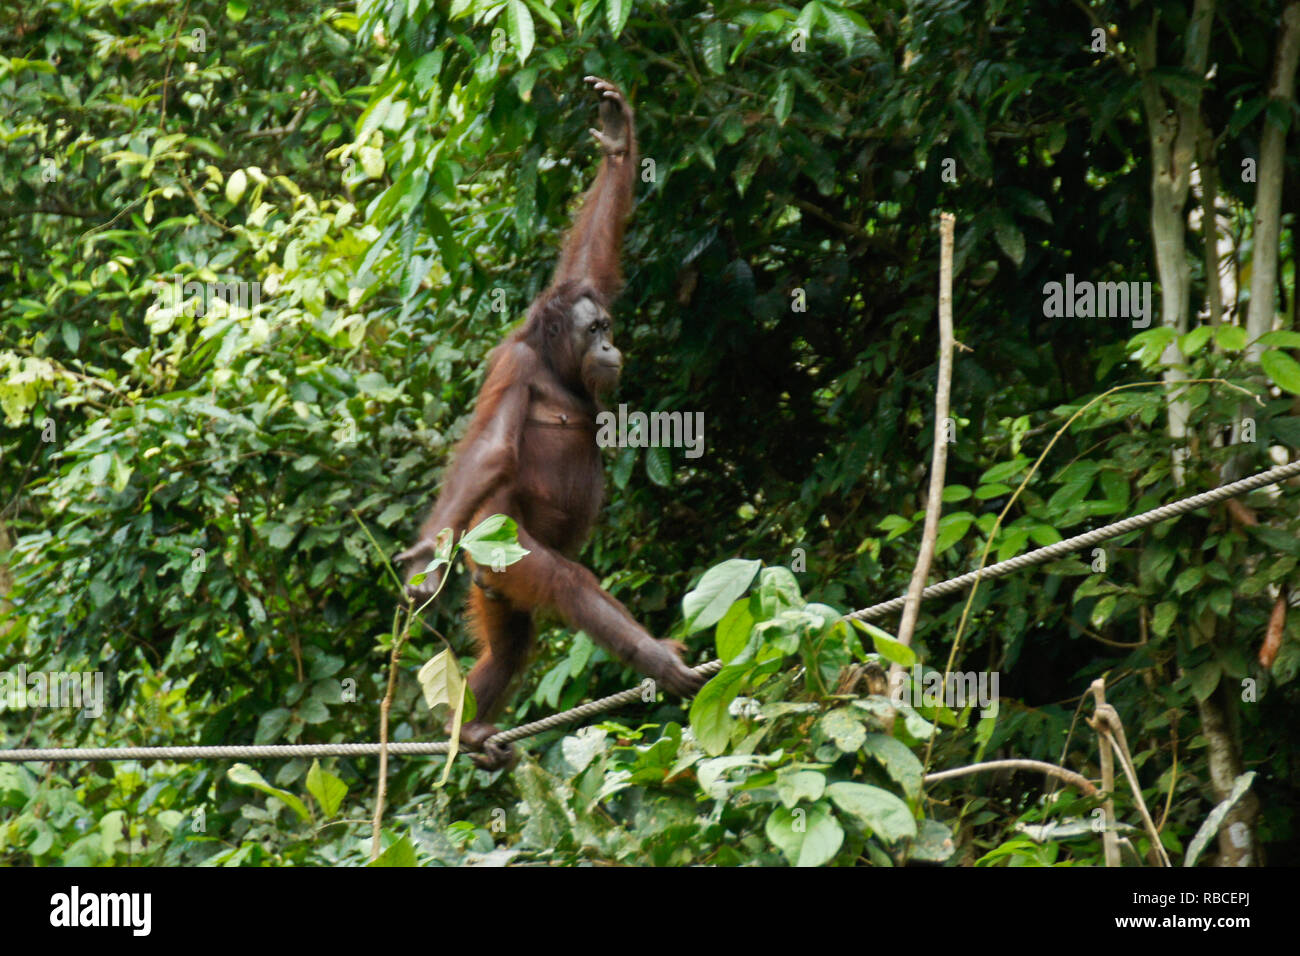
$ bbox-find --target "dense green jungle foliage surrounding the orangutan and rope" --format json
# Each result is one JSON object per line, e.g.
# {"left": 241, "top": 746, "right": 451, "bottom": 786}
{"left": 0, "top": 0, "right": 1300, "bottom": 865}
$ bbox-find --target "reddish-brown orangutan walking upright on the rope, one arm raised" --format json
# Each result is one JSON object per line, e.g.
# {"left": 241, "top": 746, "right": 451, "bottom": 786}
{"left": 398, "top": 77, "right": 703, "bottom": 767}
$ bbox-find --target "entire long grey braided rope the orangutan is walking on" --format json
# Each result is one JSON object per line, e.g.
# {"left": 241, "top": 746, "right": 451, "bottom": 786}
{"left": 0, "top": 460, "right": 1300, "bottom": 763}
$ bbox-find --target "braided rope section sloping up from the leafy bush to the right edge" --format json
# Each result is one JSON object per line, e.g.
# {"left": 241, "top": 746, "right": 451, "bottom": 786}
{"left": 845, "top": 460, "right": 1300, "bottom": 620}
